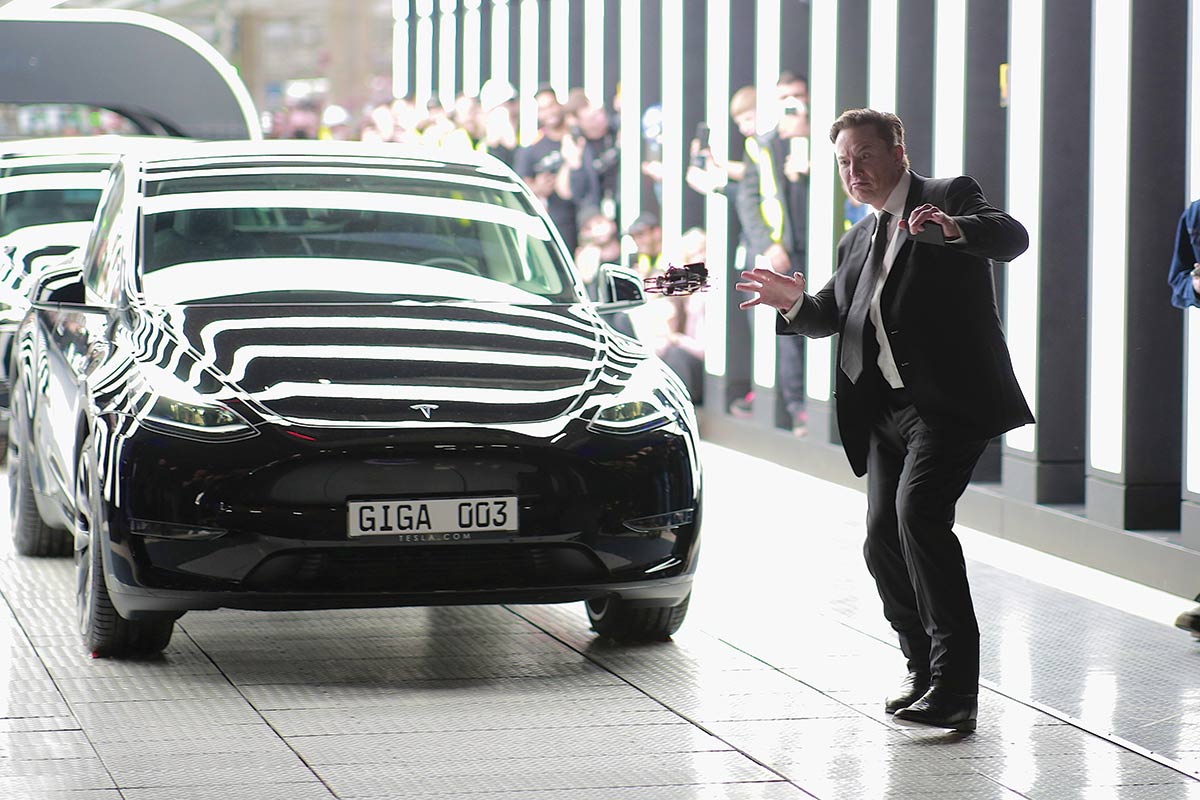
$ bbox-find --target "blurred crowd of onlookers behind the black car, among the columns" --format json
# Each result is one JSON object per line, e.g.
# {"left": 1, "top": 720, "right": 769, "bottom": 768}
{"left": 268, "top": 71, "right": 809, "bottom": 419}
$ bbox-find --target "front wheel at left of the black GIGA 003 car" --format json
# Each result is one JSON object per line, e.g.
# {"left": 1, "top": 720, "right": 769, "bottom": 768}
{"left": 74, "top": 437, "right": 176, "bottom": 658}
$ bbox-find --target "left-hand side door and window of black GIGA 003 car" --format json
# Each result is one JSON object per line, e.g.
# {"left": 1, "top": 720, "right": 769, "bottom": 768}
{"left": 34, "top": 169, "right": 127, "bottom": 506}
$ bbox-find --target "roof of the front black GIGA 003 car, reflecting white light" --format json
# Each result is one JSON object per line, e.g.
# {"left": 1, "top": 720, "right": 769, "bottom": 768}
{"left": 125, "top": 139, "right": 516, "bottom": 180}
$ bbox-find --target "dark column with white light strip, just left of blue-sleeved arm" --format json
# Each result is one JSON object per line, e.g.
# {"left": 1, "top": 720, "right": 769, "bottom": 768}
{"left": 1086, "top": 0, "right": 1188, "bottom": 530}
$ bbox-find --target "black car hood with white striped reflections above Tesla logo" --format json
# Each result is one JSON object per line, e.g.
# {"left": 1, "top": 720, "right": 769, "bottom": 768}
{"left": 150, "top": 303, "right": 630, "bottom": 427}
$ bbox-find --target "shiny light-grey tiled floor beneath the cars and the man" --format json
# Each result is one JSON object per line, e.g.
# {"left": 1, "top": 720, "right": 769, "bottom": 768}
{"left": 0, "top": 446, "right": 1200, "bottom": 800}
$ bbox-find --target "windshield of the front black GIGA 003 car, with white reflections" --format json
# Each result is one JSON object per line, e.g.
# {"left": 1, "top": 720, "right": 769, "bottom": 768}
{"left": 140, "top": 166, "right": 577, "bottom": 305}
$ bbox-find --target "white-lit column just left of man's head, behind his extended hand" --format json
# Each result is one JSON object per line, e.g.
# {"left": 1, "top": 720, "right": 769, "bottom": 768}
{"left": 804, "top": 0, "right": 870, "bottom": 443}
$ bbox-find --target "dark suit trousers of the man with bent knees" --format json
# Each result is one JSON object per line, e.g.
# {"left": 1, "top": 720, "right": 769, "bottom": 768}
{"left": 863, "top": 378, "right": 988, "bottom": 694}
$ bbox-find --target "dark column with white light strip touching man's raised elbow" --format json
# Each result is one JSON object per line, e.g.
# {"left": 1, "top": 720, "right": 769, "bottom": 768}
{"left": 1003, "top": 0, "right": 1089, "bottom": 504}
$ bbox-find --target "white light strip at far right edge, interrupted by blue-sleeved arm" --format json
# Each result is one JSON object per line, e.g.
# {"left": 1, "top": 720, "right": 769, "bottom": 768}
{"left": 1180, "top": 0, "right": 1200, "bottom": 549}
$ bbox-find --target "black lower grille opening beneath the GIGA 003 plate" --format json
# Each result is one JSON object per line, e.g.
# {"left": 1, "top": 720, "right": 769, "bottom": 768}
{"left": 242, "top": 545, "right": 607, "bottom": 594}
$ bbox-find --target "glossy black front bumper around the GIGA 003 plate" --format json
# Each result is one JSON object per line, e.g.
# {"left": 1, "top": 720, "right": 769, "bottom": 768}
{"left": 106, "top": 417, "right": 701, "bottom": 615}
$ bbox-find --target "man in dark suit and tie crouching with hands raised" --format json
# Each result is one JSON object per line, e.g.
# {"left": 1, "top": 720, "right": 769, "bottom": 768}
{"left": 738, "top": 109, "right": 1033, "bottom": 730}
